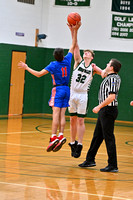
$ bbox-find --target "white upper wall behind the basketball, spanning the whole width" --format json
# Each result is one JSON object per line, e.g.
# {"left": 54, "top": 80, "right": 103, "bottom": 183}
{"left": 0, "top": 0, "right": 133, "bottom": 52}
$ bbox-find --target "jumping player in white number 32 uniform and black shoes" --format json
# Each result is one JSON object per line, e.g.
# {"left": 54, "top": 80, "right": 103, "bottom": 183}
{"left": 68, "top": 24, "right": 105, "bottom": 158}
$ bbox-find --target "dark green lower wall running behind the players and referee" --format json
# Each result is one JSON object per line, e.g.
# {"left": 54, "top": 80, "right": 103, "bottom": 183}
{"left": 0, "top": 44, "right": 133, "bottom": 121}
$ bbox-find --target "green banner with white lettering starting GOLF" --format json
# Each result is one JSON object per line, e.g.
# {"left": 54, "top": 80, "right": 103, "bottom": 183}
{"left": 111, "top": 15, "right": 133, "bottom": 39}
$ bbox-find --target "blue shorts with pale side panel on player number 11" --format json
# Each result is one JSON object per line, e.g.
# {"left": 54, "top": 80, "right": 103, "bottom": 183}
{"left": 49, "top": 86, "right": 70, "bottom": 108}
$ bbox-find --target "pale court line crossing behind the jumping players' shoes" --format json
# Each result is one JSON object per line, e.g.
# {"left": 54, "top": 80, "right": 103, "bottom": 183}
{"left": 0, "top": 142, "right": 133, "bottom": 158}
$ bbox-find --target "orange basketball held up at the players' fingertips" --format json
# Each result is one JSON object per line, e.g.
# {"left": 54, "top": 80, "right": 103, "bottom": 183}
{"left": 67, "top": 12, "right": 81, "bottom": 25}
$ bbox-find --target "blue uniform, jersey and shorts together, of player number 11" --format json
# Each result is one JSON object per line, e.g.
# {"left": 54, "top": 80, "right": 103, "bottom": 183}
{"left": 45, "top": 52, "right": 72, "bottom": 108}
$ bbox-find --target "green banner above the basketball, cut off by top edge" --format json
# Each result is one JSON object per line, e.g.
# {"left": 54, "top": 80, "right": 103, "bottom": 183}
{"left": 55, "top": 0, "right": 90, "bottom": 6}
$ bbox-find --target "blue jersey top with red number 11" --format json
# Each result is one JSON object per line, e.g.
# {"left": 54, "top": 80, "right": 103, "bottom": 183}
{"left": 44, "top": 52, "right": 72, "bottom": 85}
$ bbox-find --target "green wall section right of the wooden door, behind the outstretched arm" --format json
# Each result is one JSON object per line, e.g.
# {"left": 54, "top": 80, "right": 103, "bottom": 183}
{"left": 23, "top": 47, "right": 47, "bottom": 113}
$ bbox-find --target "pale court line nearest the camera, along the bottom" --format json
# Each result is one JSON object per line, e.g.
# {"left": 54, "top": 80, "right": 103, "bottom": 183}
{"left": 0, "top": 182, "right": 132, "bottom": 200}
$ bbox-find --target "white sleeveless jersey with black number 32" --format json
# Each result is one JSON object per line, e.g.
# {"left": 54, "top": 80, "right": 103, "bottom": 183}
{"left": 71, "top": 60, "right": 93, "bottom": 93}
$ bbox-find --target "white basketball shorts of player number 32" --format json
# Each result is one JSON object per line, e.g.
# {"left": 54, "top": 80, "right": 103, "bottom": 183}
{"left": 68, "top": 92, "right": 88, "bottom": 117}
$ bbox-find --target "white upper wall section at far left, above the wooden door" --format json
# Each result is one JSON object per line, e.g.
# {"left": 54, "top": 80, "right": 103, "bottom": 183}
{"left": 0, "top": 0, "right": 42, "bottom": 46}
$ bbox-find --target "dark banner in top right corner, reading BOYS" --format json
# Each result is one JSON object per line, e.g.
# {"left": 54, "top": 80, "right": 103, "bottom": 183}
{"left": 112, "top": 0, "right": 133, "bottom": 13}
